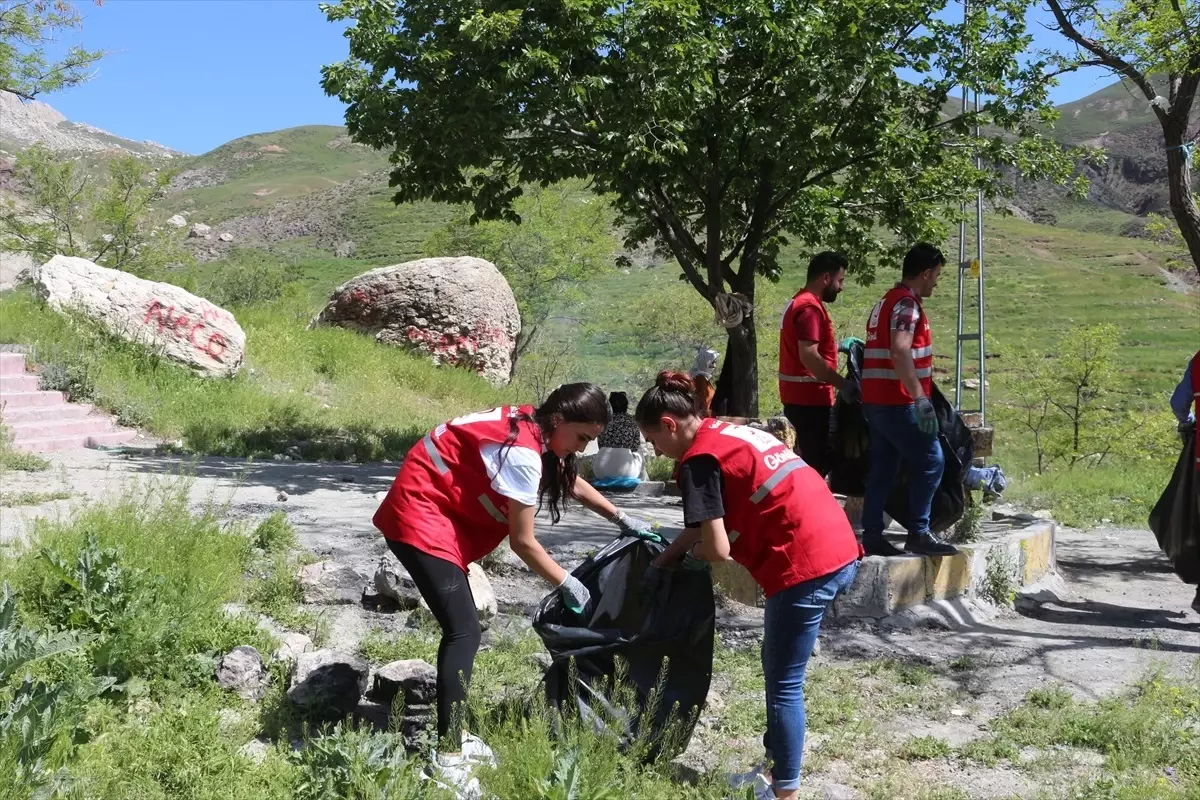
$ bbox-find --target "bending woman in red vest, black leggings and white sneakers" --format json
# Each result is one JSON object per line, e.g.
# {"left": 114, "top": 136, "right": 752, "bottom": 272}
{"left": 373, "top": 384, "right": 649, "bottom": 777}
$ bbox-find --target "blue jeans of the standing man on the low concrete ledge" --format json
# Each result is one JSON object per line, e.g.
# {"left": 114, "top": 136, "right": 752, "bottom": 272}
{"left": 863, "top": 403, "right": 944, "bottom": 539}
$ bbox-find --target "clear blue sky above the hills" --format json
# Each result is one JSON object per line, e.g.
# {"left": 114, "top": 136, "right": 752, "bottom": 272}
{"left": 43, "top": 0, "right": 1111, "bottom": 154}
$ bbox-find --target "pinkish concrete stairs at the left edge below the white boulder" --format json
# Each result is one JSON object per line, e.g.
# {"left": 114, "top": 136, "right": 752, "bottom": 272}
{"left": 0, "top": 353, "right": 137, "bottom": 452}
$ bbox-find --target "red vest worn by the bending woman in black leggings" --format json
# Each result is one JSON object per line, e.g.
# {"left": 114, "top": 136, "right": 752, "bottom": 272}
{"left": 372, "top": 405, "right": 542, "bottom": 572}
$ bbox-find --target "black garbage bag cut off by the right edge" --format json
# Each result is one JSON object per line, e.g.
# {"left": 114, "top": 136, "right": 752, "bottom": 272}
{"left": 1150, "top": 425, "right": 1200, "bottom": 584}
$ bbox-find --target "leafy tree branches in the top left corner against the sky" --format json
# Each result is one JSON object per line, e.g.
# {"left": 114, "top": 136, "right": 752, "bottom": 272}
{"left": 0, "top": 0, "right": 104, "bottom": 100}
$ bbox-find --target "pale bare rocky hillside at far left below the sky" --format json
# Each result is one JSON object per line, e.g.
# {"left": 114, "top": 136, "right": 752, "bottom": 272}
{"left": 0, "top": 91, "right": 185, "bottom": 158}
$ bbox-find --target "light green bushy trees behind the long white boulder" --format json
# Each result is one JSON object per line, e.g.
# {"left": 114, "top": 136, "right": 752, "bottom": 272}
{"left": 0, "top": 145, "right": 187, "bottom": 277}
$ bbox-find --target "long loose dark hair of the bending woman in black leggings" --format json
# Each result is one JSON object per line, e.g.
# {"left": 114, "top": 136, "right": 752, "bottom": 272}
{"left": 500, "top": 384, "right": 612, "bottom": 523}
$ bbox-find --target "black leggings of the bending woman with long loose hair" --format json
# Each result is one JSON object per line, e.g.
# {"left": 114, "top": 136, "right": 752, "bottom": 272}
{"left": 388, "top": 539, "right": 481, "bottom": 752}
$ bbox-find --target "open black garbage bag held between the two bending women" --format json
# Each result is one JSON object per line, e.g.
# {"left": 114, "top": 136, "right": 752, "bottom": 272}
{"left": 533, "top": 536, "right": 716, "bottom": 760}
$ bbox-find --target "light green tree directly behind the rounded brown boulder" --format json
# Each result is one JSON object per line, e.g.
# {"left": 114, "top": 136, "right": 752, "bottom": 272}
{"left": 424, "top": 181, "right": 618, "bottom": 371}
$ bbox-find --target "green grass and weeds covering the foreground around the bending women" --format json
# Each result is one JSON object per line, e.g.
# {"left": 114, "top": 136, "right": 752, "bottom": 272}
{"left": 0, "top": 494, "right": 1200, "bottom": 800}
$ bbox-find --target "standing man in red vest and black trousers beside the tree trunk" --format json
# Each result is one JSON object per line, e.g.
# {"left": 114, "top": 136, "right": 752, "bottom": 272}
{"left": 779, "top": 251, "right": 858, "bottom": 477}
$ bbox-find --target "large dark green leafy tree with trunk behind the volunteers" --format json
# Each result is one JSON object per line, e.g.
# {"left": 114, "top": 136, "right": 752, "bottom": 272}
{"left": 322, "top": 0, "right": 1070, "bottom": 416}
